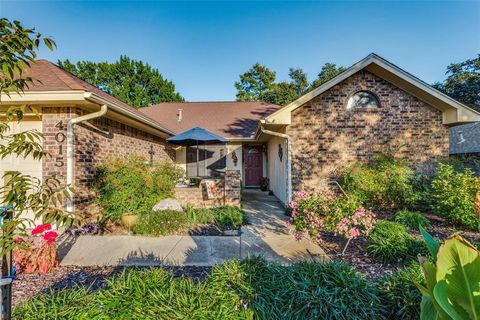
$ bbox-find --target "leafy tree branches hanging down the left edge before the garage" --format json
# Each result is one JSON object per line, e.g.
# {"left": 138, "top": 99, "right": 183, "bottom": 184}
{"left": 0, "top": 18, "right": 70, "bottom": 319}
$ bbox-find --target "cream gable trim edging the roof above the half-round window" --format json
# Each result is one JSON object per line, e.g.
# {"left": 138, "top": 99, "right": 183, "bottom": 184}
{"left": 265, "top": 53, "right": 480, "bottom": 125}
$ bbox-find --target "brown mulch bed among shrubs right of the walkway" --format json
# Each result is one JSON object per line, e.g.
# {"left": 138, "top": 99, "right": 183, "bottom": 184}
{"left": 318, "top": 212, "right": 480, "bottom": 279}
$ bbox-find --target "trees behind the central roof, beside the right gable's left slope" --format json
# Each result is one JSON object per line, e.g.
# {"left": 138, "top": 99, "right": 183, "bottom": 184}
{"left": 235, "top": 63, "right": 345, "bottom": 105}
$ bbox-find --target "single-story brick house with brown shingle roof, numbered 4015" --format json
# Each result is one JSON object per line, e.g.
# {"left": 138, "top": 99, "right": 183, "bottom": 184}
{"left": 0, "top": 54, "right": 480, "bottom": 211}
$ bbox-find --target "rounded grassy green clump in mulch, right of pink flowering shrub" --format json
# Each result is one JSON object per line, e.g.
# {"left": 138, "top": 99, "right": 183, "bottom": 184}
{"left": 367, "top": 220, "right": 427, "bottom": 263}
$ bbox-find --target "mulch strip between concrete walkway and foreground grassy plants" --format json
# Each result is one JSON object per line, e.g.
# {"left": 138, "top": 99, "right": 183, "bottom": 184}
{"left": 13, "top": 266, "right": 212, "bottom": 306}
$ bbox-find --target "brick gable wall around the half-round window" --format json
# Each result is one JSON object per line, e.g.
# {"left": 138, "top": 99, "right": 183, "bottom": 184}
{"left": 287, "top": 70, "right": 448, "bottom": 191}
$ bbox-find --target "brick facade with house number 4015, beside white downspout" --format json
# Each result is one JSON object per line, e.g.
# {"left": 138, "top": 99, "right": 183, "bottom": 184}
{"left": 42, "top": 107, "right": 175, "bottom": 205}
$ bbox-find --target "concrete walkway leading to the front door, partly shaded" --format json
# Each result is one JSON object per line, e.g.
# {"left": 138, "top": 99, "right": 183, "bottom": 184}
{"left": 59, "top": 190, "right": 325, "bottom": 266}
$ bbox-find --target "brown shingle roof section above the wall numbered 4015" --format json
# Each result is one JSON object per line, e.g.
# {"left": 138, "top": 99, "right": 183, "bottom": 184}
{"left": 15, "top": 59, "right": 172, "bottom": 134}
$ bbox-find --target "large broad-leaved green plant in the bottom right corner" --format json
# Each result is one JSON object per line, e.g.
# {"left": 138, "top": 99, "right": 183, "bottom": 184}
{"left": 417, "top": 228, "right": 480, "bottom": 320}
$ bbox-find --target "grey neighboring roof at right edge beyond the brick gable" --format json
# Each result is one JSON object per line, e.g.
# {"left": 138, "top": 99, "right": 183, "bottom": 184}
{"left": 449, "top": 122, "right": 480, "bottom": 154}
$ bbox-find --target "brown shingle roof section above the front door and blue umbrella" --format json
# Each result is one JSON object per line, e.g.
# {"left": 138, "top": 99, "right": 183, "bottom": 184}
{"left": 139, "top": 101, "right": 280, "bottom": 139}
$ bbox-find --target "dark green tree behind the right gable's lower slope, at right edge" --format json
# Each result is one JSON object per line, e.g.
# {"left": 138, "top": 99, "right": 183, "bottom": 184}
{"left": 433, "top": 54, "right": 480, "bottom": 111}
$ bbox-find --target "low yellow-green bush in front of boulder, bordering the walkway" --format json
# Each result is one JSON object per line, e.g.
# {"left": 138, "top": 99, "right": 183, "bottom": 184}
{"left": 132, "top": 210, "right": 189, "bottom": 236}
